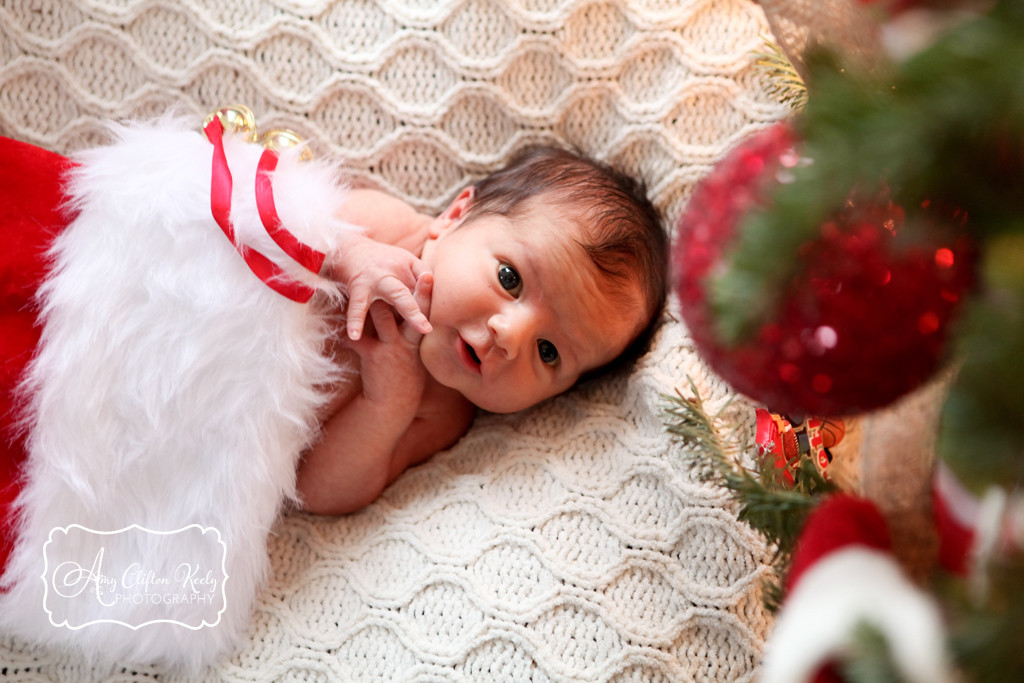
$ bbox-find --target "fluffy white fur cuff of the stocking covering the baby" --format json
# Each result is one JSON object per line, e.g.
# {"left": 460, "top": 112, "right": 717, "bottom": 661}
{"left": 0, "top": 119, "right": 348, "bottom": 671}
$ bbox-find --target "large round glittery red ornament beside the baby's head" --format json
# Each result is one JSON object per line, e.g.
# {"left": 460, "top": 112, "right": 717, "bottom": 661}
{"left": 675, "top": 124, "right": 974, "bottom": 416}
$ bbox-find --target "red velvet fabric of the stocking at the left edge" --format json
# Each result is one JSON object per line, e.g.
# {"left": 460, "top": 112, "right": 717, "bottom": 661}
{"left": 0, "top": 136, "right": 72, "bottom": 570}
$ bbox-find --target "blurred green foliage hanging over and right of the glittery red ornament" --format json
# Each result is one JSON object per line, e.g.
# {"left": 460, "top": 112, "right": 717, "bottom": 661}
{"left": 710, "top": 0, "right": 1024, "bottom": 497}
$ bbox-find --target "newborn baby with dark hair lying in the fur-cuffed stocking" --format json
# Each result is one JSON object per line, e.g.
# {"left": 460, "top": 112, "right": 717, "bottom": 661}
{"left": 298, "top": 147, "right": 667, "bottom": 514}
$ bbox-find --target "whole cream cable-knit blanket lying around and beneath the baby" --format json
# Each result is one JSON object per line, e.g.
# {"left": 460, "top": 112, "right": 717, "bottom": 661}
{"left": 0, "top": 0, "right": 784, "bottom": 681}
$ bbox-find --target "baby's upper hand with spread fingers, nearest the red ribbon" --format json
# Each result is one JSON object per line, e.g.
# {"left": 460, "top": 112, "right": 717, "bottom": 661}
{"left": 334, "top": 237, "right": 431, "bottom": 340}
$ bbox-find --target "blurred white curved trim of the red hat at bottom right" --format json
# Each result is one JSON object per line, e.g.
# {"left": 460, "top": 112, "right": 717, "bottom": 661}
{"left": 761, "top": 547, "right": 953, "bottom": 683}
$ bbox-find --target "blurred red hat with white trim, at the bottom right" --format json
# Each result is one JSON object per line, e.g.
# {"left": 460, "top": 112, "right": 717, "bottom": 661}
{"left": 761, "top": 495, "right": 952, "bottom": 683}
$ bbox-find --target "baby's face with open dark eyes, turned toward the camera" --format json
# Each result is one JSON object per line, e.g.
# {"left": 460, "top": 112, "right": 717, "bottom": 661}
{"left": 420, "top": 194, "right": 643, "bottom": 413}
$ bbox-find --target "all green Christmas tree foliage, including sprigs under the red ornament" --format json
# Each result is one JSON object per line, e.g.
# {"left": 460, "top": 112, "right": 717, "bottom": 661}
{"left": 667, "top": 0, "right": 1024, "bottom": 671}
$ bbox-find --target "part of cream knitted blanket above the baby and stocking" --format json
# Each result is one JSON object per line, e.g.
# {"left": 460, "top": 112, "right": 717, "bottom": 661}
{"left": 0, "top": 0, "right": 779, "bottom": 222}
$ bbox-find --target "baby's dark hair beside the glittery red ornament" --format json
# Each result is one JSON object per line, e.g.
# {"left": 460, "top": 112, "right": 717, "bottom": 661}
{"left": 465, "top": 145, "right": 668, "bottom": 379}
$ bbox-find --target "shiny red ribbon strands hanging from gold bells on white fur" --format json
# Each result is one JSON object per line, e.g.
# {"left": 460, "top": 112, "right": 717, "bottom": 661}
{"left": 203, "top": 117, "right": 325, "bottom": 303}
